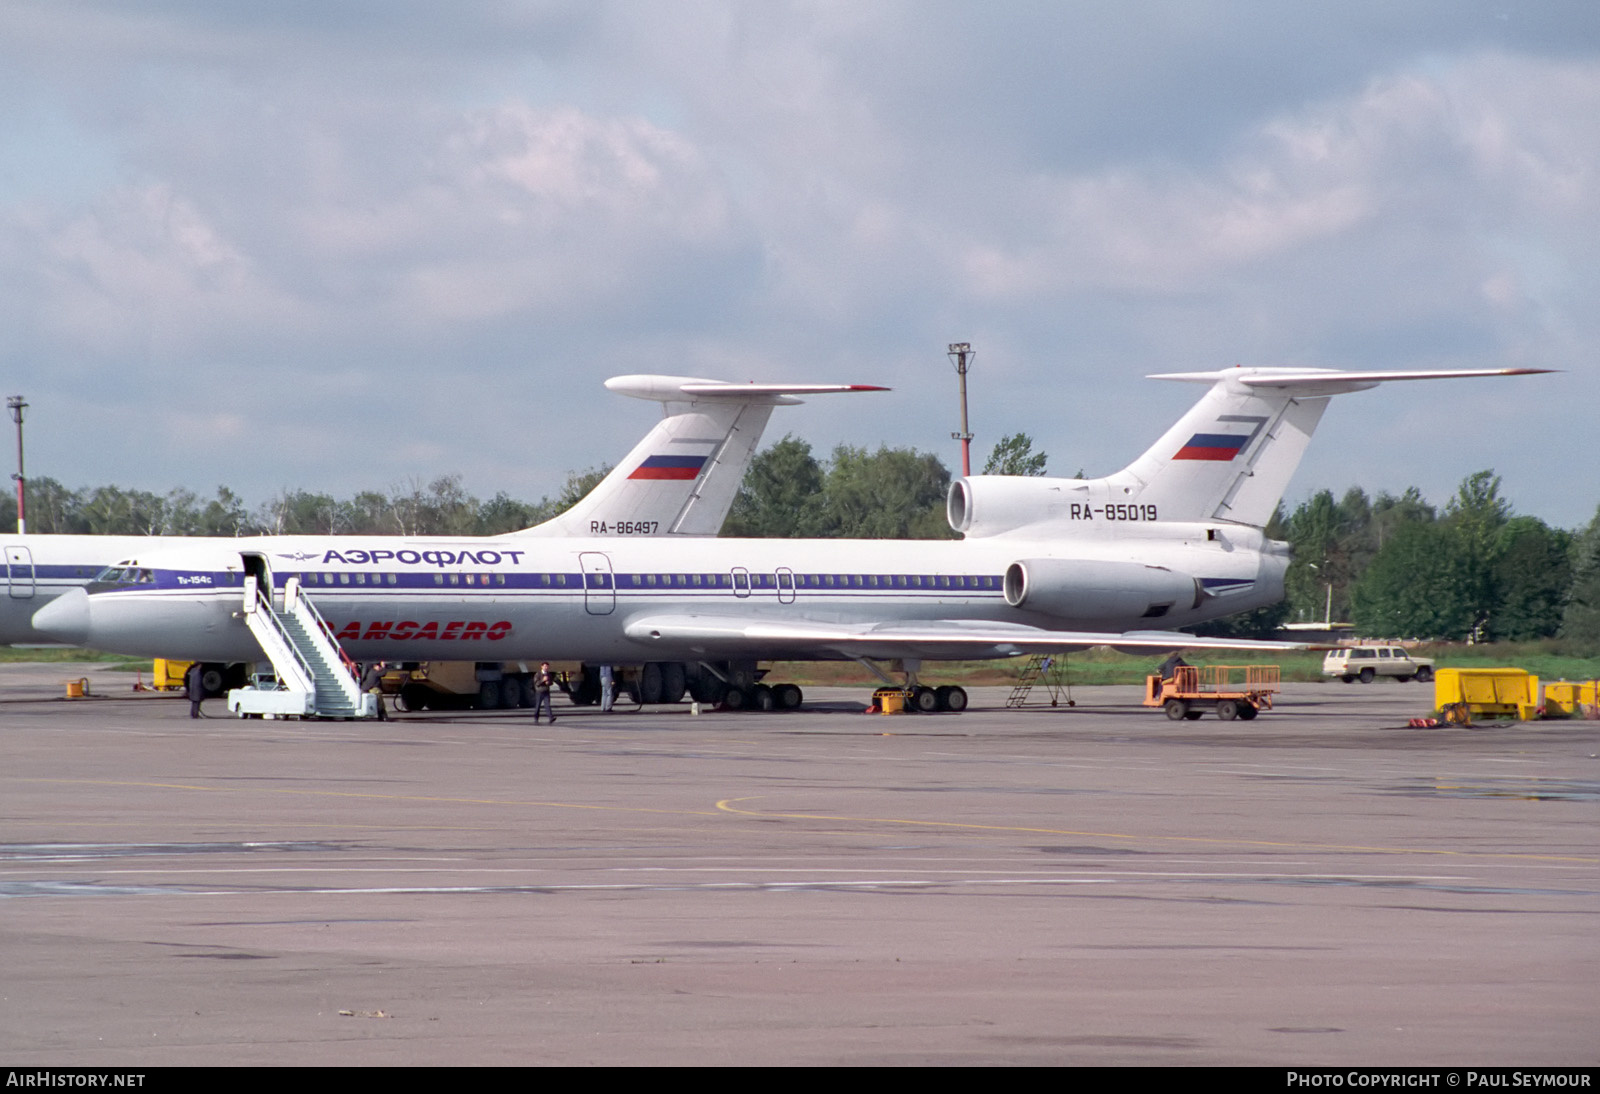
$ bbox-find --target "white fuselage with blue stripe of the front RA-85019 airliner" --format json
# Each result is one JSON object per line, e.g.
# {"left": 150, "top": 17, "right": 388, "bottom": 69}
{"left": 38, "top": 523, "right": 1286, "bottom": 662}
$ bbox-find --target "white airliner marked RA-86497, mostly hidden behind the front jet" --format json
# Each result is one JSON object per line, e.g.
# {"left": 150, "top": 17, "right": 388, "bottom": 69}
{"left": 0, "top": 374, "right": 888, "bottom": 656}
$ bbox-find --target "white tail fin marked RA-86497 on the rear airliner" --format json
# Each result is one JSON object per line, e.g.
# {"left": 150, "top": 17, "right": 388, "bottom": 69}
{"left": 512, "top": 376, "right": 888, "bottom": 536}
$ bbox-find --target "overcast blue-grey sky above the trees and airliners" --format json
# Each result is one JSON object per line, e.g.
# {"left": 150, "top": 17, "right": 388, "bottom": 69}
{"left": 0, "top": 0, "right": 1600, "bottom": 528}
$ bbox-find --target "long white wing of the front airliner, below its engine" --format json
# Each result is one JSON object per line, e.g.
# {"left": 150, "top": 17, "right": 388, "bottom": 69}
{"left": 624, "top": 614, "right": 1307, "bottom": 661}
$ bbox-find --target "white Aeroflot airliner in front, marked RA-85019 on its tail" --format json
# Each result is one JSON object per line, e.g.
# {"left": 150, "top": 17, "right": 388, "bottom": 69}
{"left": 34, "top": 368, "right": 1549, "bottom": 710}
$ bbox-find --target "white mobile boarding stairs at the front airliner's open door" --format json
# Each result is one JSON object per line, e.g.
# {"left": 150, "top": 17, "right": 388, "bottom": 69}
{"left": 227, "top": 574, "right": 378, "bottom": 718}
